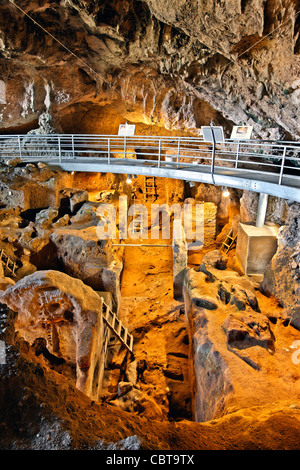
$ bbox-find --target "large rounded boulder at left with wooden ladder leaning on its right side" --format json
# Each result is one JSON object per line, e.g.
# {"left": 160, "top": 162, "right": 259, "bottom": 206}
{"left": 1, "top": 271, "right": 105, "bottom": 398}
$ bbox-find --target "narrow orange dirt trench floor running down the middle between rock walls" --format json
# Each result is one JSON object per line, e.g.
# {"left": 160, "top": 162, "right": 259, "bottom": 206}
{"left": 99, "top": 240, "right": 193, "bottom": 419}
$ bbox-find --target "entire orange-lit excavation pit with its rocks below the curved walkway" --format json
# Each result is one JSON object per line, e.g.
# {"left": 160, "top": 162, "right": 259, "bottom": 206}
{"left": 1, "top": 167, "right": 299, "bottom": 422}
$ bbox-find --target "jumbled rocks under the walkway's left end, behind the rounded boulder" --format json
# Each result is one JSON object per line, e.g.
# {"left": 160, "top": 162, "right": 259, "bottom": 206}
{"left": 0, "top": 164, "right": 123, "bottom": 311}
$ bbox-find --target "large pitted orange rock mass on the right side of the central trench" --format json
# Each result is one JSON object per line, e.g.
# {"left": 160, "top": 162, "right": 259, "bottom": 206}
{"left": 184, "top": 250, "right": 298, "bottom": 421}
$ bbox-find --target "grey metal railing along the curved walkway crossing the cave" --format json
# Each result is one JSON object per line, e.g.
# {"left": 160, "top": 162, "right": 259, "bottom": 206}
{"left": 0, "top": 134, "right": 300, "bottom": 196}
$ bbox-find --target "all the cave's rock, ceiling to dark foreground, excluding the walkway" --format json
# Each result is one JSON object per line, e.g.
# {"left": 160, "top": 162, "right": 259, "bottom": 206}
{"left": 0, "top": 0, "right": 300, "bottom": 456}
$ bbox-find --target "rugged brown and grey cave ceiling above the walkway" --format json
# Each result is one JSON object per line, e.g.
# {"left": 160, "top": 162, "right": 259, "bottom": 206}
{"left": 0, "top": 0, "right": 300, "bottom": 139}
